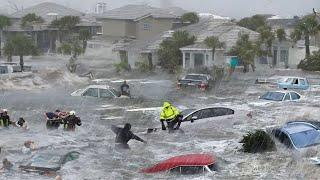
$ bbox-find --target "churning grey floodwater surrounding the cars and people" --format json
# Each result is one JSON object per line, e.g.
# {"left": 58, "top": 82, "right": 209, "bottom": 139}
{"left": 0, "top": 62, "right": 320, "bottom": 180}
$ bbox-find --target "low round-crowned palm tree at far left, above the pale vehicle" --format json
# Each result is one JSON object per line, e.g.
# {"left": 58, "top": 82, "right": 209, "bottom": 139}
{"left": 4, "top": 34, "right": 38, "bottom": 71}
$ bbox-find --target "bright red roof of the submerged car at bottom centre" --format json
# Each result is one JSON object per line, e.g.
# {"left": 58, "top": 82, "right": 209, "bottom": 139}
{"left": 141, "top": 154, "right": 216, "bottom": 173}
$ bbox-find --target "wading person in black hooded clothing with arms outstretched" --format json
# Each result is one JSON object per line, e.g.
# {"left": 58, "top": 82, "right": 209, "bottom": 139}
{"left": 111, "top": 123, "right": 147, "bottom": 149}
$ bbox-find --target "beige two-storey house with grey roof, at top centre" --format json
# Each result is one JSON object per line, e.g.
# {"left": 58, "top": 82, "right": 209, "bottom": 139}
{"left": 96, "top": 5, "right": 186, "bottom": 40}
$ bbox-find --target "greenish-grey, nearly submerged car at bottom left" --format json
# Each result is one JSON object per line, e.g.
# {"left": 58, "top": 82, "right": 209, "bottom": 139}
{"left": 19, "top": 151, "right": 80, "bottom": 173}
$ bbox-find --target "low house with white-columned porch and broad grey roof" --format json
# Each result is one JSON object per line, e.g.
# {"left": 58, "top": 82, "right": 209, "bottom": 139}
{"left": 114, "top": 18, "right": 259, "bottom": 69}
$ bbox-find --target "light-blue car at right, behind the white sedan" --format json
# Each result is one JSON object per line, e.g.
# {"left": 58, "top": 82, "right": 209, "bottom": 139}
{"left": 277, "top": 77, "right": 310, "bottom": 90}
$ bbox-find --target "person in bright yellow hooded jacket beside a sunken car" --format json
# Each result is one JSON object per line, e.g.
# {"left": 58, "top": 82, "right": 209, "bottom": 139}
{"left": 160, "top": 102, "right": 182, "bottom": 132}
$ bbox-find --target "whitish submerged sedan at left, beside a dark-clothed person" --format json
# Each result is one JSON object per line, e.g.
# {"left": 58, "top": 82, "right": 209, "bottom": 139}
{"left": 71, "top": 85, "right": 120, "bottom": 98}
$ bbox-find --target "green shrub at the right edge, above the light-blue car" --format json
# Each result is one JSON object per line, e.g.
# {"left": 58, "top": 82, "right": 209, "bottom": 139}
{"left": 298, "top": 50, "right": 320, "bottom": 71}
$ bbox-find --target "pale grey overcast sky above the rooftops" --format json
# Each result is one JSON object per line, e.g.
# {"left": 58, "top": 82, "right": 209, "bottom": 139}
{"left": 0, "top": 0, "right": 320, "bottom": 19}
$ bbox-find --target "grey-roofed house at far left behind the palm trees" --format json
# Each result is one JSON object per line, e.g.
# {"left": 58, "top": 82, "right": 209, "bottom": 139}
{"left": 5, "top": 2, "right": 101, "bottom": 52}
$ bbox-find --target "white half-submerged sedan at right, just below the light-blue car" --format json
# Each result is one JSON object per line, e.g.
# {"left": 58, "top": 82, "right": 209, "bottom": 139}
{"left": 249, "top": 91, "right": 302, "bottom": 106}
